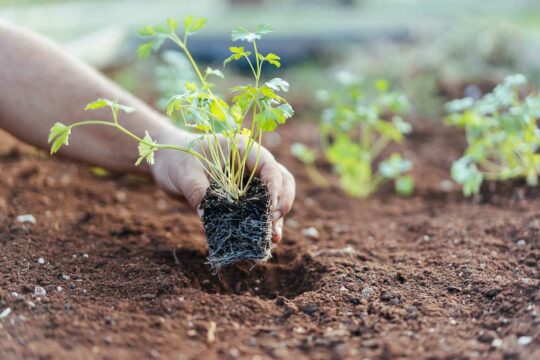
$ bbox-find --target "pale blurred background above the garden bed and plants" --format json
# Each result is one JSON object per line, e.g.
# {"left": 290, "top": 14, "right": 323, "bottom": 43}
{"left": 0, "top": 0, "right": 540, "bottom": 119}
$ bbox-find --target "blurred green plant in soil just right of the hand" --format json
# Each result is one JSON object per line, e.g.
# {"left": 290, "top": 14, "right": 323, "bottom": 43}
{"left": 293, "top": 73, "right": 414, "bottom": 197}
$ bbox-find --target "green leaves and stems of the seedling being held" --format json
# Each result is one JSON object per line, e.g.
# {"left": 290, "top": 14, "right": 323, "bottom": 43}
{"left": 49, "top": 16, "right": 293, "bottom": 201}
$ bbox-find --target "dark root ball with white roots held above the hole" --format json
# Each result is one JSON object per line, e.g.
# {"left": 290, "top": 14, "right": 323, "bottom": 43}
{"left": 202, "top": 178, "right": 272, "bottom": 272}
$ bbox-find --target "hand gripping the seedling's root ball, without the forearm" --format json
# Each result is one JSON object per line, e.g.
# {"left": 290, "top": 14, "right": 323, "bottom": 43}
{"left": 151, "top": 131, "right": 296, "bottom": 243}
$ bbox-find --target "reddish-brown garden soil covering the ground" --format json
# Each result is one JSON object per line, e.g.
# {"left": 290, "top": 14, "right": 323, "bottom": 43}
{"left": 0, "top": 117, "right": 540, "bottom": 359}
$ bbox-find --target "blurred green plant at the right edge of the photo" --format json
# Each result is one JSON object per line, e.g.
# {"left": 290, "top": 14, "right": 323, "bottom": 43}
{"left": 446, "top": 74, "right": 540, "bottom": 196}
